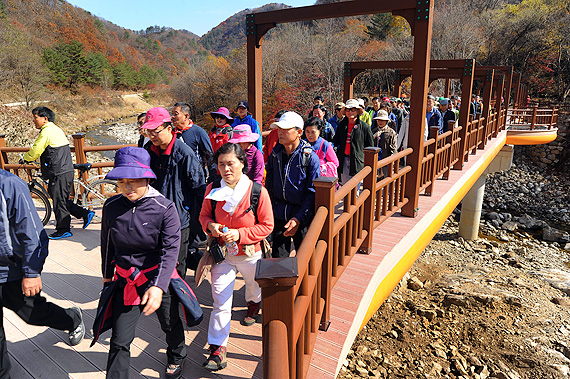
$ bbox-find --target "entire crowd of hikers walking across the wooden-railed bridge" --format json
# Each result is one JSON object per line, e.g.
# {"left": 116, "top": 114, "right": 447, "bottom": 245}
{"left": 0, "top": 95, "right": 472, "bottom": 378}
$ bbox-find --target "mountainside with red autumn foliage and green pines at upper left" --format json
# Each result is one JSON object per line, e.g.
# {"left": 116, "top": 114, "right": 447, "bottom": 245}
{"left": 0, "top": 0, "right": 210, "bottom": 100}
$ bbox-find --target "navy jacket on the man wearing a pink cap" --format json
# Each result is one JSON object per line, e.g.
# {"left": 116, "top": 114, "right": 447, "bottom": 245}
{"left": 145, "top": 138, "right": 206, "bottom": 229}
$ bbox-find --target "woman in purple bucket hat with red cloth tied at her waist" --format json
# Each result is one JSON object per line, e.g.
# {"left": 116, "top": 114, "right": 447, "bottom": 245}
{"left": 101, "top": 147, "right": 185, "bottom": 378}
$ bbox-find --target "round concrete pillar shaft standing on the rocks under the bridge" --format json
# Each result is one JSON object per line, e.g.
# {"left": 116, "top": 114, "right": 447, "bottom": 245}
{"left": 459, "top": 173, "right": 487, "bottom": 240}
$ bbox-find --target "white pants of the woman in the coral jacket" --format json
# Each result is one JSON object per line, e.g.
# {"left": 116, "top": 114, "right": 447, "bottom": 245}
{"left": 208, "top": 251, "right": 261, "bottom": 346}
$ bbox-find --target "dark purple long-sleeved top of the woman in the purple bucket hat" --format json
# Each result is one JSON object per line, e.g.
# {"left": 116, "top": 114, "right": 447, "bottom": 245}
{"left": 101, "top": 187, "right": 180, "bottom": 292}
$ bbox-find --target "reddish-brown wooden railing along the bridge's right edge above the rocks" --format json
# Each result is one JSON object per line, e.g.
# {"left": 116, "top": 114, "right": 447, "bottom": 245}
{"left": 256, "top": 104, "right": 556, "bottom": 379}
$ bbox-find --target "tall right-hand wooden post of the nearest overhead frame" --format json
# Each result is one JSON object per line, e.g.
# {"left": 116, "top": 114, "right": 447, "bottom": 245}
{"left": 402, "top": 0, "right": 434, "bottom": 217}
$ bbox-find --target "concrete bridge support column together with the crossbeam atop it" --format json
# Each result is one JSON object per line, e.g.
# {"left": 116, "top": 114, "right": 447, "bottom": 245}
{"left": 459, "top": 145, "right": 513, "bottom": 240}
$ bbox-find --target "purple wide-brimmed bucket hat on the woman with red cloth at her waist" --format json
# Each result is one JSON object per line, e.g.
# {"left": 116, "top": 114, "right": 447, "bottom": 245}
{"left": 105, "top": 146, "right": 156, "bottom": 180}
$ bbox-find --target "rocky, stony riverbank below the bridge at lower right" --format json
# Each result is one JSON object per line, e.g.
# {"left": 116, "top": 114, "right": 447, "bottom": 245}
{"left": 338, "top": 147, "right": 570, "bottom": 379}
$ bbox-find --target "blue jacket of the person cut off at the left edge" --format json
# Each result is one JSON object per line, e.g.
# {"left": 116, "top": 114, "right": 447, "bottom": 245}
{"left": 0, "top": 170, "right": 49, "bottom": 283}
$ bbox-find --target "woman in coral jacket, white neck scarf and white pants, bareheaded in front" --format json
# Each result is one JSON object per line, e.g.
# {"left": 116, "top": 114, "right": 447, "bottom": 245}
{"left": 200, "top": 143, "right": 274, "bottom": 371}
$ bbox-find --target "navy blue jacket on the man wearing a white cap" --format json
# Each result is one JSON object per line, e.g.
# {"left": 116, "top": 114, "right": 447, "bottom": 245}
{"left": 265, "top": 141, "right": 321, "bottom": 225}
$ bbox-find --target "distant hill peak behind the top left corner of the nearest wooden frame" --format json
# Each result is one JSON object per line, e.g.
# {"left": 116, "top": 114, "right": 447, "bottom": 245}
{"left": 200, "top": 3, "right": 290, "bottom": 56}
